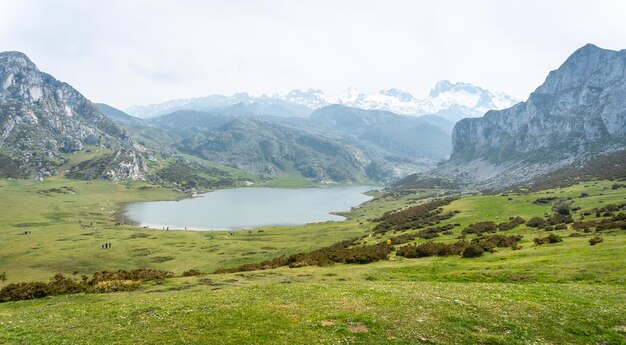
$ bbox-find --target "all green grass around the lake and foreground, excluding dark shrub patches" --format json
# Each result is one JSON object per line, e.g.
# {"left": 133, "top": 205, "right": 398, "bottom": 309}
{"left": 0, "top": 179, "right": 626, "bottom": 344}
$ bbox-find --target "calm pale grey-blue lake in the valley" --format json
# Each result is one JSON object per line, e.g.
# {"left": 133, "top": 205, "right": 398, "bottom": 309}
{"left": 124, "top": 186, "right": 376, "bottom": 230}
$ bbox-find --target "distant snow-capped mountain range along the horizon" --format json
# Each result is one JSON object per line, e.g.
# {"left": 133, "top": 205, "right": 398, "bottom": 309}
{"left": 127, "top": 80, "right": 519, "bottom": 122}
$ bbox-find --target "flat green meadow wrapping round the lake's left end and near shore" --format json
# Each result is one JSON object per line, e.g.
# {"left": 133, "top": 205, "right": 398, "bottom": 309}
{"left": 0, "top": 179, "right": 363, "bottom": 283}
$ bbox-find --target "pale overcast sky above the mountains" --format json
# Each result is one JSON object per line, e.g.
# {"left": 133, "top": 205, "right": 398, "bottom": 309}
{"left": 0, "top": 0, "right": 626, "bottom": 109}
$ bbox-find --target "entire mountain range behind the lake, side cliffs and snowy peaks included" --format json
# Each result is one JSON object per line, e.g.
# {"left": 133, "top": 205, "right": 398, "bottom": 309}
{"left": 0, "top": 45, "right": 626, "bottom": 189}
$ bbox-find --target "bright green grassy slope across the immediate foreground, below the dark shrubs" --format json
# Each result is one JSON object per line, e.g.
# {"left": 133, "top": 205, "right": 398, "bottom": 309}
{"left": 0, "top": 273, "right": 626, "bottom": 344}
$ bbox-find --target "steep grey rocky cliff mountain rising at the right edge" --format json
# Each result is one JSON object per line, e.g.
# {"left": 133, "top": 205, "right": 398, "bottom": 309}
{"left": 439, "top": 44, "right": 626, "bottom": 187}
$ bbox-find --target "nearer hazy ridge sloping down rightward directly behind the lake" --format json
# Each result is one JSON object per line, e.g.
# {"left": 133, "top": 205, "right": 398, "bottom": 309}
{"left": 152, "top": 111, "right": 366, "bottom": 181}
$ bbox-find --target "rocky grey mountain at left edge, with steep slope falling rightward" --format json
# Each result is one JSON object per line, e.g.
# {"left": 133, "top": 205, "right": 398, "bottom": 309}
{"left": 0, "top": 52, "right": 144, "bottom": 179}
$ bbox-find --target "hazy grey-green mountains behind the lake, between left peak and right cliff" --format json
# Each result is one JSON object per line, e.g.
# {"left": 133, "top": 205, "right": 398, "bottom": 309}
{"left": 140, "top": 105, "right": 451, "bottom": 182}
